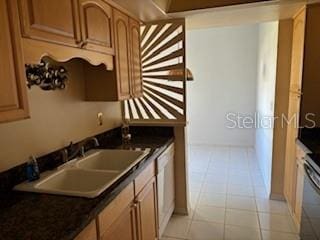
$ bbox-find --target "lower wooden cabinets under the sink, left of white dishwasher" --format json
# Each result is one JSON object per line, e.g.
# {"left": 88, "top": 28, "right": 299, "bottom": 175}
{"left": 76, "top": 162, "right": 158, "bottom": 240}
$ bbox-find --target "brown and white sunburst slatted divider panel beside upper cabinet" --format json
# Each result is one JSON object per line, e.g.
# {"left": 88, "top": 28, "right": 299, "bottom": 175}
{"left": 123, "top": 19, "right": 187, "bottom": 125}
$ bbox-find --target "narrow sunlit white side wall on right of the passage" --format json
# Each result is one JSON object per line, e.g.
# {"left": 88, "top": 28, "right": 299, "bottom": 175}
{"left": 255, "top": 22, "right": 278, "bottom": 192}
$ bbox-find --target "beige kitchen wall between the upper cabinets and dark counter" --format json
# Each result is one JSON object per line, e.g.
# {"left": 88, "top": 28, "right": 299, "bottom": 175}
{"left": 0, "top": 60, "right": 122, "bottom": 172}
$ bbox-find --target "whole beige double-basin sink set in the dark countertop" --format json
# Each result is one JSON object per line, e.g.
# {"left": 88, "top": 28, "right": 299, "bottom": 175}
{"left": 14, "top": 150, "right": 148, "bottom": 198}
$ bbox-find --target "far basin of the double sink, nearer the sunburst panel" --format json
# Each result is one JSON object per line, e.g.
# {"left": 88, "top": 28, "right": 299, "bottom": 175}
{"left": 77, "top": 150, "right": 147, "bottom": 172}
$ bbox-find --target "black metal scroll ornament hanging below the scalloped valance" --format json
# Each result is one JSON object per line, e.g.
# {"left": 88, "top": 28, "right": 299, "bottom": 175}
{"left": 25, "top": 61, "right": 67, "bottom": 91}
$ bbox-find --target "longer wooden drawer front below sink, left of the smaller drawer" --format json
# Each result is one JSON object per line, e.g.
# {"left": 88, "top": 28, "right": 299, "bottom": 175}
{"left": 97, "top": 183, "right": 134, "bottom": 236}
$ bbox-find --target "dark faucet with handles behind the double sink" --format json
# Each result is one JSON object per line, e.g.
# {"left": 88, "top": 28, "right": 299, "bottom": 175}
{"left": 60, "top": 137, "right": 100, "bottom": 163}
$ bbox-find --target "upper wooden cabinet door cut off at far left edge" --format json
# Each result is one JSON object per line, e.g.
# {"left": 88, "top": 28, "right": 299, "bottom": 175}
{"left": 0, "top": 0, "right": 28, "bottom": 122}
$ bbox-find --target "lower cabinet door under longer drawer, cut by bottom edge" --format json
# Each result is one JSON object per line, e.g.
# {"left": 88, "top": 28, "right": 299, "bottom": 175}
{"left": 100, "top": 207, "right": 137, "bottom": 240}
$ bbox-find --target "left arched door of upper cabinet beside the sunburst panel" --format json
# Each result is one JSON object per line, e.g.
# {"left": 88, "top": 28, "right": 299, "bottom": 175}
{"left": 113, "top": 9, "right": 131, "bottom": 100}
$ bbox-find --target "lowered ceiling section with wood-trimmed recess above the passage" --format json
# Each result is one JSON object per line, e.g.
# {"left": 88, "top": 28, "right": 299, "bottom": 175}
{"left": 113, "top": 0, "right": 320, "bottom": 29}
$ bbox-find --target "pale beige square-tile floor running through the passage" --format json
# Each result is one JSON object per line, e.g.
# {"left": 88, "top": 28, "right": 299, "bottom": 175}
{"left": 161, "top": 146, "right": 299, "bottom": 240}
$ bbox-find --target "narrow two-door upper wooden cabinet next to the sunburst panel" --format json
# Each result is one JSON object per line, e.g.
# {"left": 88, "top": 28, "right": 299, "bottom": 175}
{"left": 84, "top": 9, "right": 142, "bottom": 101}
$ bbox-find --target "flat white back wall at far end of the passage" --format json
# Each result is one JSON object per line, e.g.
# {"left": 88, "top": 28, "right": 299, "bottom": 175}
{"left": 186, "top": 25, "right": 258, "bottom": 146}
